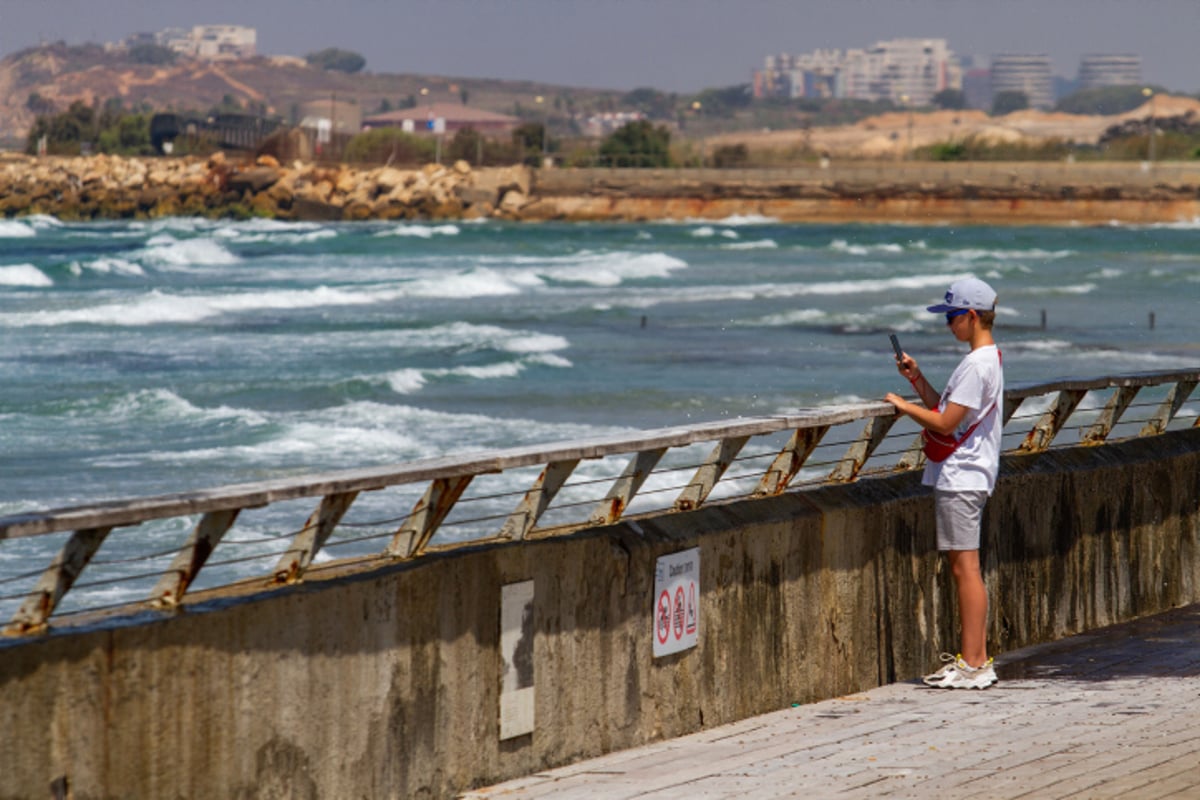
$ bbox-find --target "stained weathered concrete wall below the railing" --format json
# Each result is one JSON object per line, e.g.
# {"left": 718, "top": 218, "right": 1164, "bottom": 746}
{"left": 0, "top": 429, "right": 1200, "bottom": 800}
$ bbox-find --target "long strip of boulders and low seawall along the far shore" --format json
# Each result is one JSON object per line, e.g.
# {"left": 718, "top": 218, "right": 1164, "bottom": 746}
{"left": 0, "top": 154, "right": 1200, "bottom": 225}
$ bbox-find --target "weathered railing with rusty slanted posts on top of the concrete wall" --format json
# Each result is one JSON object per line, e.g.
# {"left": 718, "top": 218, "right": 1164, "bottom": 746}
{"left": 0, "top": 368, "right": 1200, "bottom": 637}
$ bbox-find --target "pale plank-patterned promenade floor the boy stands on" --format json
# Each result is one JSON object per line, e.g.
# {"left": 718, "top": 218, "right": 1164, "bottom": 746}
{"left": 463, "top": 604, "right": 1200, "bottom": 800}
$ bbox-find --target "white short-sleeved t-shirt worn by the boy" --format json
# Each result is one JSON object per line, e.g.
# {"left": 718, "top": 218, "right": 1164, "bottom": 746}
{"left": 922, "top": 344, "right": 1004, "bottom": 494}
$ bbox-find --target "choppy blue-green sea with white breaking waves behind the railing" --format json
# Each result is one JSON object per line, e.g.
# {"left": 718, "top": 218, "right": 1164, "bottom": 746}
{"left": 0, "top": 216, "right": 1200, "bottom": 624}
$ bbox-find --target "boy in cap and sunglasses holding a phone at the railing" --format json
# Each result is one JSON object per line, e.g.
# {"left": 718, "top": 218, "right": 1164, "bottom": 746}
{"left": 884, "top": 278, "right": 1004, "bottom": 688}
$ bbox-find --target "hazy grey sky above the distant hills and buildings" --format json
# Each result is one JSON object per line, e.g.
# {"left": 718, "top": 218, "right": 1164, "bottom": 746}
{"left": 0, "top": 0, "right": 1200, "bottom": 92}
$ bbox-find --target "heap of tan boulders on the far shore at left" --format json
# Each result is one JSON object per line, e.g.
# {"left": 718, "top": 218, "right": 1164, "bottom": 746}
{"left": 0, "top": 152, "right": 530, "bottom": 219}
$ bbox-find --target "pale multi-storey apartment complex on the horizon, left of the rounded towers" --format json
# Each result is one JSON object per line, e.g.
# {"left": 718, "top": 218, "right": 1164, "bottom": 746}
{"left": 755, "top": 38, "right": 962, "bottom": 106}
